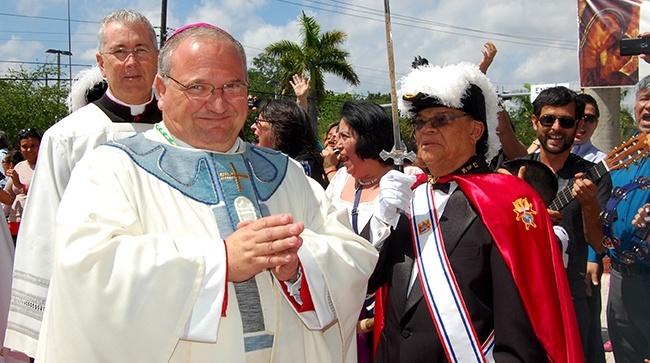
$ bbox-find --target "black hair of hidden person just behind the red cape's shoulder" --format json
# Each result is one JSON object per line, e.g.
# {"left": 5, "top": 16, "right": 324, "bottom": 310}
{"left": 501, "top": 159, "right": 558, "bottom": 207}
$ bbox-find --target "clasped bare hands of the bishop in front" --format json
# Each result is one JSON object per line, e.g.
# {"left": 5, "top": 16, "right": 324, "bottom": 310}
{"left": 225, "top": 214, "right": 305, "bottom": 282}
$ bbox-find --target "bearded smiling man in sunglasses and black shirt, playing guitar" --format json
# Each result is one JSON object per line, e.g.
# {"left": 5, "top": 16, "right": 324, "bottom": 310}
{"left": 525, "top": 86, "right": 611, "bottom": 362}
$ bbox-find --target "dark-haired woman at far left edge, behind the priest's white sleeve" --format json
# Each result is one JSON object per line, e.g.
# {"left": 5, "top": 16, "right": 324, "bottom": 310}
{"left": 0, "top": 128, "right": 41, "bottom": 243}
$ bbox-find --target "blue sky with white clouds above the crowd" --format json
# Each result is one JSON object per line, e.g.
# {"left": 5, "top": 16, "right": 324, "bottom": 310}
{"left": 0, "top": 0, "right": 578, "bottom": 94}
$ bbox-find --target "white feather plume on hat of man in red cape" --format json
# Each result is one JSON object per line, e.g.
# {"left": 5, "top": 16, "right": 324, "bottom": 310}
{"left": 397, "top": 62, "right": 501, "bottom": 161}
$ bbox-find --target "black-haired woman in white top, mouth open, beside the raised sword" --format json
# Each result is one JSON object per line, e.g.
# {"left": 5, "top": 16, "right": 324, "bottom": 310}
{"left": 326, "top": 101, "right": 415, "bottom": 362}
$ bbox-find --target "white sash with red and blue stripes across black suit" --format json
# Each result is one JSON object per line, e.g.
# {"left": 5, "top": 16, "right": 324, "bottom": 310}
{"left": 411, "top": 183, "right": 494, "bottom": 363}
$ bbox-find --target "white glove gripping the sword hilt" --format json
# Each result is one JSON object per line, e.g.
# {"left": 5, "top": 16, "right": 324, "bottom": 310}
{"left": 375, "top": 170, "right": 416, "bottom": 228}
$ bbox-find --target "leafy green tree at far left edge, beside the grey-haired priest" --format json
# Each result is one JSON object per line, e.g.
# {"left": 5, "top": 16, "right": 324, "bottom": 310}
{"left": 0, "top": 65, "right": 68, "bottom": 148}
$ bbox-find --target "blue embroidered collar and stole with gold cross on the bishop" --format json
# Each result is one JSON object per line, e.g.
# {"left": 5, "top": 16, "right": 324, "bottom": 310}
{"left": 108, "top": 134, "right": 289, "bottom": 352}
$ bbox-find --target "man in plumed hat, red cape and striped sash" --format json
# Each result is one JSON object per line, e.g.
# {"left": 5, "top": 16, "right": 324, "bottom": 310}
{"left": 369, "top": 63, "right": 583, "bottom": 362}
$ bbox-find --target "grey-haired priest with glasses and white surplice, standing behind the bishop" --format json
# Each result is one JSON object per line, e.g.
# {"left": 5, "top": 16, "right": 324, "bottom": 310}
{"left": 5, "top": 10, "right": 162, "bottom": 357}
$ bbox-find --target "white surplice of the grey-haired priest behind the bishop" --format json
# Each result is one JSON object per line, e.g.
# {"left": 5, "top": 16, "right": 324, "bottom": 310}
{"left": 5, "top": 104, "right": 151, "bottom": 357}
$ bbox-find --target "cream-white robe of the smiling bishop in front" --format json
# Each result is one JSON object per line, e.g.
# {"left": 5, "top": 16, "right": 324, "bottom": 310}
{"left": 37, "top": 130, "right": 377, "bottom": 363}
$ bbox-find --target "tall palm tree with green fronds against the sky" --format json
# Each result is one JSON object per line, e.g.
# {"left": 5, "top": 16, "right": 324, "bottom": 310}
{"left": 266, "top": 11, "right": 359, "bottom": 130}
